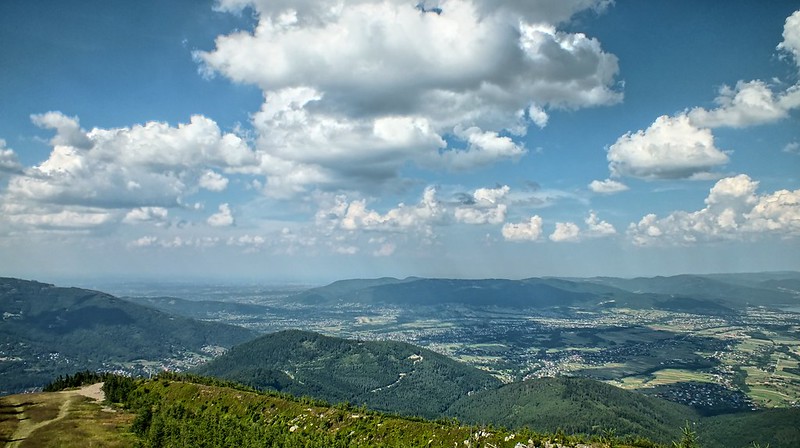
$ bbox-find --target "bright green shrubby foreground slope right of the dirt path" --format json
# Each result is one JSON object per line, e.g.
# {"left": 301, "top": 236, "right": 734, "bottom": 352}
{"left": 94, "top": 377, "right": 652, "bottom": 448}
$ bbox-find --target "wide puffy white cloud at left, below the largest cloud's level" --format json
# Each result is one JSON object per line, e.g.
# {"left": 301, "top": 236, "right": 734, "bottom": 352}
{"left": 2, "top": 112, "right": 256, "bottom": 212}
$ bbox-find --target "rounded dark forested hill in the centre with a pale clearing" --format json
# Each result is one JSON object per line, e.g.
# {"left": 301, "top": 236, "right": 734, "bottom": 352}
{"left": 196, "top": 330, "right": 500, "bottom": 418}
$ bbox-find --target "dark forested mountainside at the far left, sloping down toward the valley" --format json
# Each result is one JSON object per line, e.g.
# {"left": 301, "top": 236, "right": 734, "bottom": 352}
{"left": 0, "top": 278, "right": 256, "bottom": 394}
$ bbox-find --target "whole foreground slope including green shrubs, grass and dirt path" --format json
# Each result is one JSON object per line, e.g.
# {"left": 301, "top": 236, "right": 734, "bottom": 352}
{"left": 0, "top": 373, "right": 798, "bottom": 448}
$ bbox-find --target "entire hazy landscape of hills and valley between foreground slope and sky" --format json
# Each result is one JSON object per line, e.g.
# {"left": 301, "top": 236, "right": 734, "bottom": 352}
{"left": 0, "top": 273, "right": 800, "bottom": 447}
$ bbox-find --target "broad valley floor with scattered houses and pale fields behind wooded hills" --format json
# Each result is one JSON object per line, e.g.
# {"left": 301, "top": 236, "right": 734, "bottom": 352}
{"left": 117, "top": 274, "right": 800, "bottom": 415}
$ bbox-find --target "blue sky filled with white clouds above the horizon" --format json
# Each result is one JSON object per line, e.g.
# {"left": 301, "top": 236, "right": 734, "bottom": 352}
{"left": 0, "top": 0, "right": 800, "bottom": 282}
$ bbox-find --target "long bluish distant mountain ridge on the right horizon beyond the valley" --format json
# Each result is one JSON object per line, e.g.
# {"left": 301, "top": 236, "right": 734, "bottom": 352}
{"left": 292, "top": 272, "right": 800, "bottom": 314}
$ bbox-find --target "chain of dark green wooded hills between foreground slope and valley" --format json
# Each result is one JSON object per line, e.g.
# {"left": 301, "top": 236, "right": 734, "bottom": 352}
{"left": 196, "top": 330, "right": 800, "bottom": 448}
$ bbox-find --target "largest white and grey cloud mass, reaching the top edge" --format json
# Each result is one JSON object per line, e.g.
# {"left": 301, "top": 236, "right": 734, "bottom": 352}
{"left": 195, "top": 0, "right": 622, "bottom": 197}
